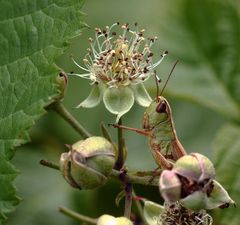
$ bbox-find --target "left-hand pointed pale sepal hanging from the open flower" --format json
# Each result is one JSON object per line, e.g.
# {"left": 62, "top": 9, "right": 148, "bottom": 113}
{"left": 76, "top": 84, "right": 102, "bottom": 108}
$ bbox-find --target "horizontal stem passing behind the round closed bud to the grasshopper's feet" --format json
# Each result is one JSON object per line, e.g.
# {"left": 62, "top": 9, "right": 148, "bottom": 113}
{"left": 40, "top": 160, "right": 159, "bottom": 186}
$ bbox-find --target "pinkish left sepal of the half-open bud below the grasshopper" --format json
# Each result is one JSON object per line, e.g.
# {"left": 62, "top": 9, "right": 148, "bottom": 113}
{"left": 159, "top": 170, "right": 181, "bottom": 202}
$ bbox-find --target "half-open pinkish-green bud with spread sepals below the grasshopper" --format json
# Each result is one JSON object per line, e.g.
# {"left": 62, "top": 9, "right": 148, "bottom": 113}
{"left": 159, "top": 153, "right": 234, "bottom": 211}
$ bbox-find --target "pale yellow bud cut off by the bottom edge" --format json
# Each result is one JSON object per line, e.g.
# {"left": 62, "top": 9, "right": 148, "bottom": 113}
{"left": 97, "top": 214, "right": 133, "bottom": 225}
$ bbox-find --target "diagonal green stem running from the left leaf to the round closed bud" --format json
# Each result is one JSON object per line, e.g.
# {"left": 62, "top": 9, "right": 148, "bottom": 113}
{"left": 49, "top": 102, "right": 92, "bottom": 139}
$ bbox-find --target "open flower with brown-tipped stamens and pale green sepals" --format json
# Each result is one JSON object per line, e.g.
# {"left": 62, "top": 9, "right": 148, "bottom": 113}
{"left": 73, "top": 23, "right": 167, "bottom": 119}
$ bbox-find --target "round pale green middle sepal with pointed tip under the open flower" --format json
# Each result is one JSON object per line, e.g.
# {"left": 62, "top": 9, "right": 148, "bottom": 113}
{"left": 103, "top": 87, "right": 134, "bottom": 122}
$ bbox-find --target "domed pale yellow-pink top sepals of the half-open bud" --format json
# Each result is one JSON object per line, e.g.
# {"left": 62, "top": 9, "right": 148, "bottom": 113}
{"left": 173, "top": 153, "right": 215, "bottom": 182}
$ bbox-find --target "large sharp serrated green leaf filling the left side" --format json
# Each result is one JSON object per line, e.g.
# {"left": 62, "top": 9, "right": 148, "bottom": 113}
{"left": 0, "top": 0, "right": 84, "bottom": 222}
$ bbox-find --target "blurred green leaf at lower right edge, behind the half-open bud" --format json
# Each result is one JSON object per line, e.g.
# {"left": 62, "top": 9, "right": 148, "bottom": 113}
{"left": 213, "top": 124, "right": 240, "bottom": 225}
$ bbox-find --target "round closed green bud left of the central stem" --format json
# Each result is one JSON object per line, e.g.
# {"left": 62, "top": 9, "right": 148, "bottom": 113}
{"left": 60, "top": 137, "right": 115, "bottom": 189}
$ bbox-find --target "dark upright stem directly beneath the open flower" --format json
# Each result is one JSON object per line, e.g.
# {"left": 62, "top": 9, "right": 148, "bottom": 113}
{"left": 114, "top": 118, "right": 124, "bottom": 170}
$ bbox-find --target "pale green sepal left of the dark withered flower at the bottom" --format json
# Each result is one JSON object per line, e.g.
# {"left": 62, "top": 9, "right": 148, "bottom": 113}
{"left": 143, "top": 201, "right": 164, "bottom": 225}
